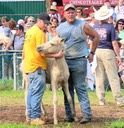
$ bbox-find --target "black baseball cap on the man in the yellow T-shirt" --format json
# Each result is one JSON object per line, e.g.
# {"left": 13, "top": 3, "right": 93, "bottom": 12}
{"left": 38, "top": 12, "right": 50, "bottom": 24}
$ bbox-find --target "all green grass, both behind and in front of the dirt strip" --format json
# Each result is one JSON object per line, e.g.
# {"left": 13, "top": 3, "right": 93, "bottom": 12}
{"left": 0, "top": 89, "right": 124, "bottom": 128}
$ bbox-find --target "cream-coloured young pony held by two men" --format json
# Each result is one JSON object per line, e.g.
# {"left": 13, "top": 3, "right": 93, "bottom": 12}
{"left": 20, "top": 37, "right": 78, "bottom": 124}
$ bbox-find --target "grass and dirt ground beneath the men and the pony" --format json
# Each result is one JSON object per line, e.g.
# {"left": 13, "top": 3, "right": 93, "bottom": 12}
{"left": 0, "top": 88, "right": 124, "bottom": 128}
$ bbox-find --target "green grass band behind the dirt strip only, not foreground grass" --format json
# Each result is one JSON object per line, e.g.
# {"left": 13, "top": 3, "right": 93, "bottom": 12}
{"left": 0, "top": 90, "right": 124, "bottom": 106}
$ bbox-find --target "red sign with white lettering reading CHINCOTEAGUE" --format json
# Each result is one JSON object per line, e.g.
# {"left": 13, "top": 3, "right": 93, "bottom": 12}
{"left": 63, "top": 0, "right": 117, "bottom": 6}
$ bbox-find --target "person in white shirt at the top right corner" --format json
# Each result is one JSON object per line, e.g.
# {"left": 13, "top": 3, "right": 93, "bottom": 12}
{"left": 115, "top": 0, "right": 124, "bottom": 22}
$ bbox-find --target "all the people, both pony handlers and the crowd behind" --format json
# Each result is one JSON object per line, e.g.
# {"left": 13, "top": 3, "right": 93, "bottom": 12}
{"left": 0, "top": 0, "right": 124, "bottom": 125}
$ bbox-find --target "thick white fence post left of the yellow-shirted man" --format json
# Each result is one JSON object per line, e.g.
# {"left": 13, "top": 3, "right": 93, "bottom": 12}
{"left": 13, "top": 53, "right": 17, "bottom": 90}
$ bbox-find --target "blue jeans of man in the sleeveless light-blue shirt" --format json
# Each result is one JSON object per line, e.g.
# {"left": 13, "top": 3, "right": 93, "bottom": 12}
{"left": 64, "top": 58, "right": 92, "bottom": 118}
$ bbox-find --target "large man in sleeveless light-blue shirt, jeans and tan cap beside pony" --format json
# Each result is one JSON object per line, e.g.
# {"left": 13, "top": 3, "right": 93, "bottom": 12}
{"left": 57, "top": 4, "right": 99, "bottom": 124}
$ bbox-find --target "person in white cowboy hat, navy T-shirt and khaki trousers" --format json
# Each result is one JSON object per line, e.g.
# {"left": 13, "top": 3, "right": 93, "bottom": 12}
{"left": 93, "top": 6, "right": 124, "bottom": 105}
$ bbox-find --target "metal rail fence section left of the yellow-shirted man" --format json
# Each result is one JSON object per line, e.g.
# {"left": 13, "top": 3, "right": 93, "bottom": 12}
{"left": 0, "top": 50, "right": 23, "bottom": 90}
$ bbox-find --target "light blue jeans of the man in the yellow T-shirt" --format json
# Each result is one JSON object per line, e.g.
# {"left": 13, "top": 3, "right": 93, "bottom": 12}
{"left": 27, "top": 68, "right": 46, "bottom": 120}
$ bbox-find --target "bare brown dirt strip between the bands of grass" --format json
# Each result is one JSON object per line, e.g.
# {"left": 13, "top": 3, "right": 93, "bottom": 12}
{"left": 0, "top": 103, "right": 124, "bottom": 128}
